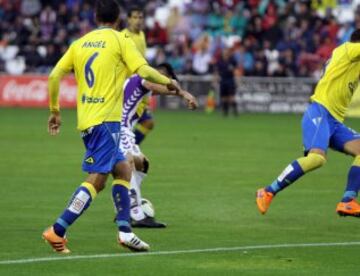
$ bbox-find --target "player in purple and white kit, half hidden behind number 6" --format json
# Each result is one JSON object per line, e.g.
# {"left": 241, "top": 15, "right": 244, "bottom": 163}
{"left": 120, "top": 63, "right": 197, "bottom": 228}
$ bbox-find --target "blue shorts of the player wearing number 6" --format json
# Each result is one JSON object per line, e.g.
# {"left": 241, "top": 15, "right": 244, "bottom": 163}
{"left": 81, "top": 122, "right": 126, "bottom": 174}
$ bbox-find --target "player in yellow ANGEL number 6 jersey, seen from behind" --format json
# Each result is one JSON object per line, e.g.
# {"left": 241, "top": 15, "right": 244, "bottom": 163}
{"left": 43, "top": 0, "right": 180, "bottom": 253}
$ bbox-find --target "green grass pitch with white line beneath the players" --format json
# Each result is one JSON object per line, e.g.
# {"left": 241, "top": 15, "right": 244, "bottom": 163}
{"left": 0, "top": 109, "right": 360, "bottom": 275}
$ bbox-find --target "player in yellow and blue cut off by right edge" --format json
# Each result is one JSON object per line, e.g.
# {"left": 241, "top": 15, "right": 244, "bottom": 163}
{"left": 256, "top": 29, "right": 360, "bottom": 217}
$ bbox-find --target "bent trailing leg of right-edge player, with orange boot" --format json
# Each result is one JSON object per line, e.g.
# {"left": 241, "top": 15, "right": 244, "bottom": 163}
{"left": 256, "top": 104, "right": 332, "bottom": 214}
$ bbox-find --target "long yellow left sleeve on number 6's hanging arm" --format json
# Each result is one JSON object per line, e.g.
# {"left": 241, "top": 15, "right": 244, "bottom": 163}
{"left": 48, "top": 46, "right": 73, "bottom": 112}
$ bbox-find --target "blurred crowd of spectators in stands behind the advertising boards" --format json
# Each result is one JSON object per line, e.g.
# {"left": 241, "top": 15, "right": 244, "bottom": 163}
{"left": 0, "top": 0, "right": 360, "bottom": 78}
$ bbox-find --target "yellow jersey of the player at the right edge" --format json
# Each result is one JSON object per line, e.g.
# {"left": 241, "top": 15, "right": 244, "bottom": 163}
{"left": 311, "top": 42, "right": 360, "bottom": 122}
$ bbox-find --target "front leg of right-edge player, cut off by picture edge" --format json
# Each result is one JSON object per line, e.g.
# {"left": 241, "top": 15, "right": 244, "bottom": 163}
{"left": 330, "top": 123, "right": 360, "bottom": 217}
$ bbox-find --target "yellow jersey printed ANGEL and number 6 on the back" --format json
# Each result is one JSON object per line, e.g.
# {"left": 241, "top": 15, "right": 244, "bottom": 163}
{"left": 51, "top": 27, "right": 147, "bottom": 130}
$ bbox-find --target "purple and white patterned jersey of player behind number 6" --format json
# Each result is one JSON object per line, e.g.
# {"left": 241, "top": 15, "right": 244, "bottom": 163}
{"left": 121, "top": 75, "right": 151, "bottom": 129}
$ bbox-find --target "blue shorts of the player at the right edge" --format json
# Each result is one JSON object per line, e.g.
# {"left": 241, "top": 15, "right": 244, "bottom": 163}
{"left": 302, "top": 103, "right": 360, "bottom": 154}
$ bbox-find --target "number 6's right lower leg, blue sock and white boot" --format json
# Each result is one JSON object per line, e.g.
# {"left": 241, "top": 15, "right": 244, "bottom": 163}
{"left": 112, "top": 158, "right": 150, "bottom": 251}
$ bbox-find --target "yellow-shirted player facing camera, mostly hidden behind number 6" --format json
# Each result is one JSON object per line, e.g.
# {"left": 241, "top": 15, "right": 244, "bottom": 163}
{"left": 123, "top": 6, "right": 155, "bottom": 145}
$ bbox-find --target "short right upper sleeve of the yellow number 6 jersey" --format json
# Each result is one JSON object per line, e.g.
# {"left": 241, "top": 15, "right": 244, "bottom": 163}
{"left": 122, "top": 35, "right": 147, "bottom": 73}
